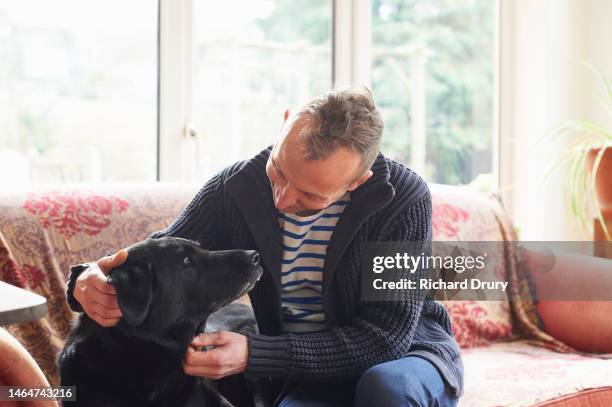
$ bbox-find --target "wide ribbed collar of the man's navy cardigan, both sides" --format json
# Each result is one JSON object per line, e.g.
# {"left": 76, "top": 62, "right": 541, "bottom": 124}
{"left": 225, "top": 146, "right": 395, "bottom": 298}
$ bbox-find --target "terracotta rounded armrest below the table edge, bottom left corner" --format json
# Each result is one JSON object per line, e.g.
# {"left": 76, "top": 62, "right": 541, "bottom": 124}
{"left": 0, "top": 328, "right": 58, "bottom": 407}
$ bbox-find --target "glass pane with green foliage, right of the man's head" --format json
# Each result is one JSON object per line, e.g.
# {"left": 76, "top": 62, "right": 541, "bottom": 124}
{"left": 372, "top": 0, "right": 495, "bottom": 187}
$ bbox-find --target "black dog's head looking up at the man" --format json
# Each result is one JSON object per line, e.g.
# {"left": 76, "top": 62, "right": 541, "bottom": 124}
{"left": 108, "top": 237, "right": 262, "bottom": 340}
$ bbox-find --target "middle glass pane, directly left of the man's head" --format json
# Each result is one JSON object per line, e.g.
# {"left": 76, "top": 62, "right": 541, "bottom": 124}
{"left": 193, "top": 0, "right": 332, "bottom": 177}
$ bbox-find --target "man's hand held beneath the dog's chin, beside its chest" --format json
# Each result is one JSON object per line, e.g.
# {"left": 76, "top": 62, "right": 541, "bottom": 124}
{"left": 183, "top": 331, "right": 249, "bottom": 380}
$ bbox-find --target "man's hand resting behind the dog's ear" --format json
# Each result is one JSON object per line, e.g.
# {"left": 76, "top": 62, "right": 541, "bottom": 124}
{"left": 74, "top": 249, "right": 127, "bottom": 327}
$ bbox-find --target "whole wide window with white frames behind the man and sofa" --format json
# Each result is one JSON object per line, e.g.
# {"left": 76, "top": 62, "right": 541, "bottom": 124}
{"left": 0, "top": 0, "right": 499, "bottom": 187}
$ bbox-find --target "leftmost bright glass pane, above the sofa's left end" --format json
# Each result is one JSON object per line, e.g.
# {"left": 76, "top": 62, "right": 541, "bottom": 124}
{"left": 0, "top": 0, "right": 157, "bottom": 185}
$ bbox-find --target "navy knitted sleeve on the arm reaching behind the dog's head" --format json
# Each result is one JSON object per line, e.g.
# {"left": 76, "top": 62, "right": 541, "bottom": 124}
{"left": 66, "top": 174, "right": 223, "bottom": 312}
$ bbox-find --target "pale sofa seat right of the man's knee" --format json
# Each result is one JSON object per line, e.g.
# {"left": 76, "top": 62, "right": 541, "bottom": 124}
{"left": 459, "top": 341, "right": 612, "bottom": 407}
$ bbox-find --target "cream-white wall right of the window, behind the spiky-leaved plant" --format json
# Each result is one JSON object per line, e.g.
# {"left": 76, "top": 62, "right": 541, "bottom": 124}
{"left": 500, "top": 0, "right": 612, "bottom": 240}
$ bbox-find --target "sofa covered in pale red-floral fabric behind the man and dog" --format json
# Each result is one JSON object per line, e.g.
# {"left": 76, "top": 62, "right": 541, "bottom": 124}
{"left": 0, "top": 183, "right": 612, "bottom": 407}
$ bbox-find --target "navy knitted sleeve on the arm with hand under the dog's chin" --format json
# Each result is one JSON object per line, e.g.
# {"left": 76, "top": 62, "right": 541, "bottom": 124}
{"left": 241, "top": 191, "right": 431, "bottom": 380}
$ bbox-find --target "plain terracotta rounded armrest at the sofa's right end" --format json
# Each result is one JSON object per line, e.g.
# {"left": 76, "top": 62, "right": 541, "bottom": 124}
{"left": 525, "top": 250, "right": 612, "bottom": 353}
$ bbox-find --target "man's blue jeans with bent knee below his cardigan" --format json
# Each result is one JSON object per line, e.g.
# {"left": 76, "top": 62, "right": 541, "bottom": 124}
{"left": 278, "top": 356, "right": 457, "bottom": 407}
